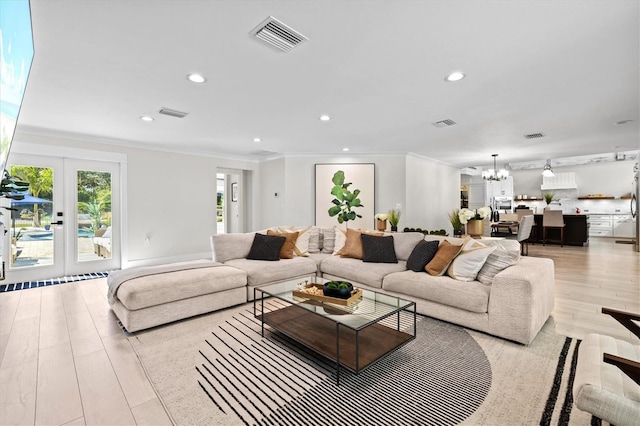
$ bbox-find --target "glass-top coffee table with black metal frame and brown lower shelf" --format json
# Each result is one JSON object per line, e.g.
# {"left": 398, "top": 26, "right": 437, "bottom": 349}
{"left": 253, "top": 278, "right": 416, "bottom": 385}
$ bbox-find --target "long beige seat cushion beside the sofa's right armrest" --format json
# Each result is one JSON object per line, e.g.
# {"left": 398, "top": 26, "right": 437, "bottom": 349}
{"left": 382, "top": 271, "right": 491, "bottom": 314}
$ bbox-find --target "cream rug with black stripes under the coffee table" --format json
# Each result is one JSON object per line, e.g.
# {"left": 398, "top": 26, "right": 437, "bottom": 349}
{"left": 129, "top": 304, "right": 590, "bottom": 426}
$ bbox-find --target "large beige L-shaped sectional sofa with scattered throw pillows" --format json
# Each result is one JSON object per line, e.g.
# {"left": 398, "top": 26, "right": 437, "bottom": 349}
{"left": 110, "top": 227, "right": 555, "bottom": 344}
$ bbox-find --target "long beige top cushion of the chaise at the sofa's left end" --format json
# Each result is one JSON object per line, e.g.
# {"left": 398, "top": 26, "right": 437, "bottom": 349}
{"left": 117, "top": 265, "right": 247, "bottom": 310}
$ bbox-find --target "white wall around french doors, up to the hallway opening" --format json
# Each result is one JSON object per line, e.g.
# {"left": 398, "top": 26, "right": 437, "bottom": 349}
{"left": 12, "top": 134, "right": 260, "bottom": 266}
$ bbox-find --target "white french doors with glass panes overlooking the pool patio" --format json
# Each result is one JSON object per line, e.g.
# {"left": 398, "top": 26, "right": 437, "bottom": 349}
{"left": 3, "top": 154, "right": 121, "bottom": 283}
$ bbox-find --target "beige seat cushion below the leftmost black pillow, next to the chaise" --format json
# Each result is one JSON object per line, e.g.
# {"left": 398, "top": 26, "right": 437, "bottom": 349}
{"left": 225, "top": 256, "right": 318, "bottom": 286}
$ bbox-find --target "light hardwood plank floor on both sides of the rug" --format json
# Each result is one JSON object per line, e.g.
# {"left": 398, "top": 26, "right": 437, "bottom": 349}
{"left": 0, "top": 238, "right": 640, "bottom": 425}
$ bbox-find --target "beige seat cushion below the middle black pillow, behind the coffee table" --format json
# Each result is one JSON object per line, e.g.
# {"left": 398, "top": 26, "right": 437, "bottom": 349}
{"left": 320, "top": 256, "right": 407, "bottom": 288}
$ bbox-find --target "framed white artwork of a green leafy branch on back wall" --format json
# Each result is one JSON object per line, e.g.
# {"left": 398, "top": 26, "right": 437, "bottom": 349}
{"left": 315, "top": 163, "right": 375, "bottom": 229}
